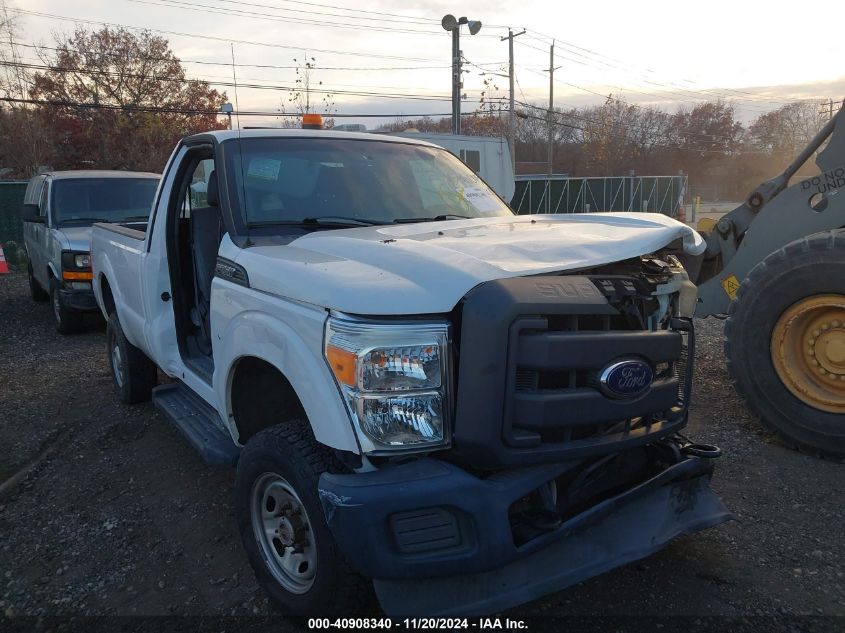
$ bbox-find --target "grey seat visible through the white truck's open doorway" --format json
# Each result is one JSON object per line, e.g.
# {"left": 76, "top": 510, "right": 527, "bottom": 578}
{"left": 191, "top": 171, "right": 222, "bottom": 353}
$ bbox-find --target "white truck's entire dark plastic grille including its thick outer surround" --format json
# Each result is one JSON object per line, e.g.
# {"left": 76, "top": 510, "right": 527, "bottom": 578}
{"left": 453, "top": 275, "right": 693, "bottom": 469}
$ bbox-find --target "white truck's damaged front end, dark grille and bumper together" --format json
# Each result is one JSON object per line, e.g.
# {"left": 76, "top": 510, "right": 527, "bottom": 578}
{"left": 320, "top": 252, "right": 731, "bottom": 616}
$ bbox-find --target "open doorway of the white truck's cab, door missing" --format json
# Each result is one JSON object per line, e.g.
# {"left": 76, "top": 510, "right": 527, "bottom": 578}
{"left": 167, "top": 145, "right": 226, "bottom": 382}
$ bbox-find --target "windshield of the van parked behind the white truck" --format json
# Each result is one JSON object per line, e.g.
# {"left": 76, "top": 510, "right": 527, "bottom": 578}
{"left": 51, "top": 178, "right": 158, "bottom": 226}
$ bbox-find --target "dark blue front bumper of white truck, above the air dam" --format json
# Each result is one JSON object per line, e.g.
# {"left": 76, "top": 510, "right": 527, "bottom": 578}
{"left": 318, "top": 450, "right": 727, "bottom": 579}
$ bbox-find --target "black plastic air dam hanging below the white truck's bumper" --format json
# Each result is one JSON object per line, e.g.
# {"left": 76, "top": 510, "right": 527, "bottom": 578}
{"left": 373, "top": 466, "right": 733, "bottom": 617}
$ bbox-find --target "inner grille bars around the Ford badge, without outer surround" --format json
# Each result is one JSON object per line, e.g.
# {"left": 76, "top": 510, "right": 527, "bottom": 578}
{"left": 502, "top": 315, "right": 692, "bottom": 453}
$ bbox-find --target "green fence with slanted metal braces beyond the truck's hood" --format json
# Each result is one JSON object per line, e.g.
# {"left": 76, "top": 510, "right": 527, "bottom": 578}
{"left": 511, "top": 175, "right": 687, "bottom": 216}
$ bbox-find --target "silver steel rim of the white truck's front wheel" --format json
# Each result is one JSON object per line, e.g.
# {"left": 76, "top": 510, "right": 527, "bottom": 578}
{"left": 250, "top": 473, "right": 317, "bottom": 594}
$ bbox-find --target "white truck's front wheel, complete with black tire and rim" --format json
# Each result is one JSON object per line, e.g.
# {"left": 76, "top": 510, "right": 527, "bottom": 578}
{"left": 235, "top": 418, "right": 372, "bottom": 616}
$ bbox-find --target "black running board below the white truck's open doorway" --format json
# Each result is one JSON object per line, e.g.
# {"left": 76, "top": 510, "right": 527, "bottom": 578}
{"left": 153, "top": 383, "right": 241, "bottom": 466}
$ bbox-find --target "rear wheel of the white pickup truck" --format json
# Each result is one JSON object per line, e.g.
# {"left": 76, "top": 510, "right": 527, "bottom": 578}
{"left": 106, "top": 312, "right": 158, "bottom": 404}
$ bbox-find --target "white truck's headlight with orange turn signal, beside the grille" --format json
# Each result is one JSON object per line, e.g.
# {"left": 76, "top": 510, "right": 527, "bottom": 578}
{"left": 325, "top": 317, "right": 449, "bottom": 453}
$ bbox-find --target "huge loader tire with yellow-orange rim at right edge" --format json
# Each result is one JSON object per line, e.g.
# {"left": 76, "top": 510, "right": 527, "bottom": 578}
{"left": 725, "top": 230, "right": 845, "bottom": 456}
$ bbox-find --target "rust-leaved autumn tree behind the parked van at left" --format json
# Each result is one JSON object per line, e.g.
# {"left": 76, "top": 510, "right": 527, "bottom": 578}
{"left": 31, "top": 27, "right": 226, "bottom": 171}
